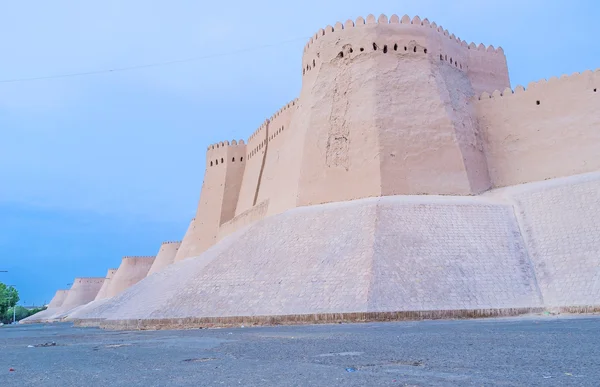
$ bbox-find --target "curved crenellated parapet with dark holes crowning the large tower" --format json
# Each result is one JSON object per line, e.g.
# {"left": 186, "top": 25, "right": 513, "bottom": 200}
{"left": 302, "top": 15, "right": 510, "bottom": 93}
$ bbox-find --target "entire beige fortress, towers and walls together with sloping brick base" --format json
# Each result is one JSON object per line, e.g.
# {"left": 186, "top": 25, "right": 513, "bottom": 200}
{"left": 30, "top": 15, "right": 600, "bottom": 328}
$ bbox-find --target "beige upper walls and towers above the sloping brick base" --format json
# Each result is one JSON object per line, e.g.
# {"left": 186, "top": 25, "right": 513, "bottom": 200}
{"left": 176, "top": 15, "right": 600, "bottom": 261}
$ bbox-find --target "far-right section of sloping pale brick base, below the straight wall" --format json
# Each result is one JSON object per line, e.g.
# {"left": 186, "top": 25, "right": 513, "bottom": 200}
{"left": 492, "top": 173, "right": 600, "bottom": 307}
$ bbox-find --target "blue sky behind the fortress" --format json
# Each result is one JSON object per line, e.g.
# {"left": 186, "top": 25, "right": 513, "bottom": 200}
{"left": 0, "top": 0, "right": 600, "bottom": 304}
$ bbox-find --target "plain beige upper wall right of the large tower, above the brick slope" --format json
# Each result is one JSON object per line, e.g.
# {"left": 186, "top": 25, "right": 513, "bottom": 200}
{"left": 476, "top": 70, "right": 600, "bottom": 187}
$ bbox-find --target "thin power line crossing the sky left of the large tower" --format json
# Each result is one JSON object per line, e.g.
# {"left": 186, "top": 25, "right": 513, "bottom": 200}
{"left": 0, "top": 37, "right": 309, "bottom": 83}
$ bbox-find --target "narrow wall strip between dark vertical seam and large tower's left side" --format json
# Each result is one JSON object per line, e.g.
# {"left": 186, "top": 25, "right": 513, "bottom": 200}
{"left": 256, "top": 101, "right": 296, "bottom": 208}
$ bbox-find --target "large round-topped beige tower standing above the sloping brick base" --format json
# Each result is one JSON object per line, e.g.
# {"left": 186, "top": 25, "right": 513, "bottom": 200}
{"left": 292, "top": 15, "right": 509, "bottom": 205}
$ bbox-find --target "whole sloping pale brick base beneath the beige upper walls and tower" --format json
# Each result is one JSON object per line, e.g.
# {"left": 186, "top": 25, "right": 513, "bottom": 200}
{"left": 69, "top": 172, "right": 600, "bottom": 329}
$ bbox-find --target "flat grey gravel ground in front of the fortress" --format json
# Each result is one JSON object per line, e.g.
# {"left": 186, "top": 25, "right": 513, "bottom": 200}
{"left": 0, "top": 316, "right": 600, "bottom": 387}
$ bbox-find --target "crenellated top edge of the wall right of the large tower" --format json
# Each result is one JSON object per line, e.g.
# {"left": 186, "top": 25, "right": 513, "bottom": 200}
{"left": 478, "top": 68, "right": 600, "bottom": 101}
